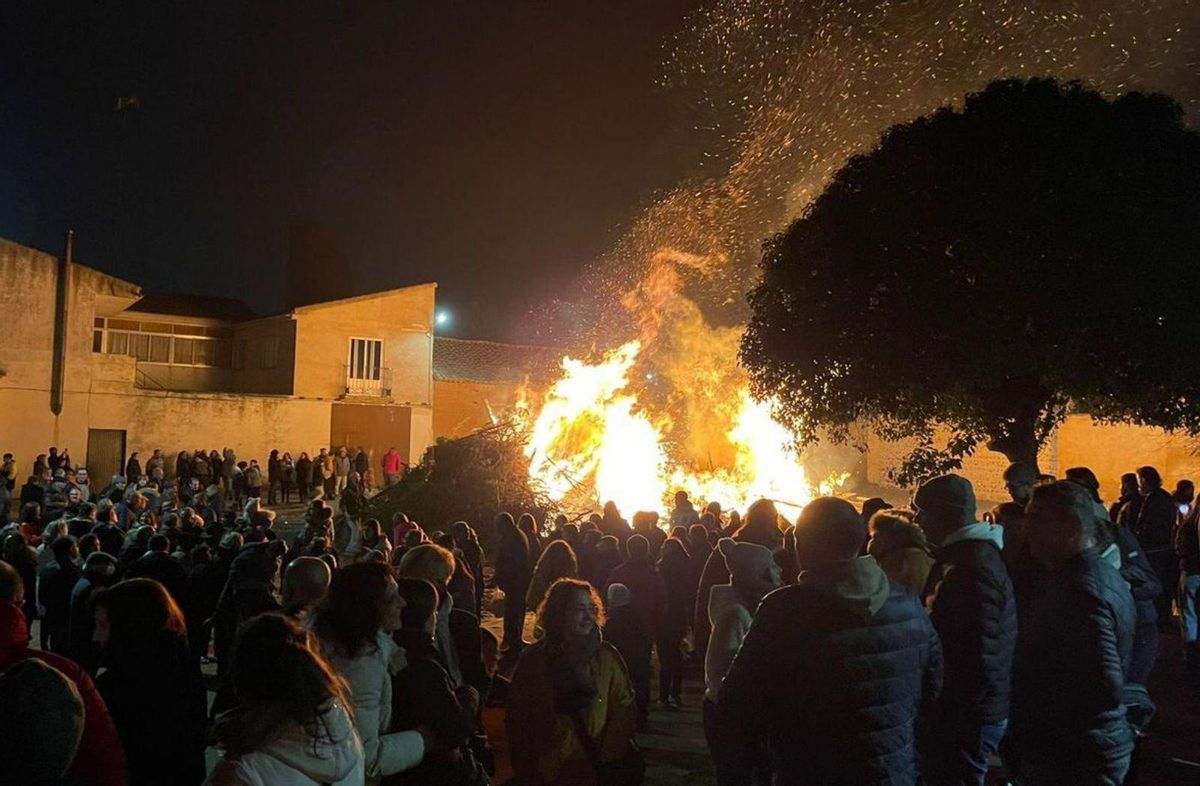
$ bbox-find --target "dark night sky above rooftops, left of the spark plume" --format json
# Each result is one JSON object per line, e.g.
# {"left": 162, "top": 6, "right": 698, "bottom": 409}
{"left": 0, "top": 0, "right": 700, "bottom": 338}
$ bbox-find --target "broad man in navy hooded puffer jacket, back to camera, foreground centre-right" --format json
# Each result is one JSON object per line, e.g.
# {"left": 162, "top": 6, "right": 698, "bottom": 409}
{"left": 716, "top": 497, "right": 942, "bottom": 786}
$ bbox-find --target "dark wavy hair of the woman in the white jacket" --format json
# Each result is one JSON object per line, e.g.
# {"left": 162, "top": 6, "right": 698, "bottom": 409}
{"left": 313, "top": 562, "right": 392, "bottom": 658}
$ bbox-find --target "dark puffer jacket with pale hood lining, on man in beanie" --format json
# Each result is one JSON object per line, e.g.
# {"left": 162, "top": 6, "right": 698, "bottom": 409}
{"left": 928, "top": 523, "right": 1016, "bottom": 727}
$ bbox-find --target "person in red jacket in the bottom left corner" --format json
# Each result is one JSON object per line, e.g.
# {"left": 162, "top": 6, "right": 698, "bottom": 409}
{"left": 0, "top": 562, "right": 128, "bottom": 786}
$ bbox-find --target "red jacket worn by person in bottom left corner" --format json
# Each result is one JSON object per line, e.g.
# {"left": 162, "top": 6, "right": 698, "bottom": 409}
{"left": 0, "top": 601, "right": 128, "bottom": 786}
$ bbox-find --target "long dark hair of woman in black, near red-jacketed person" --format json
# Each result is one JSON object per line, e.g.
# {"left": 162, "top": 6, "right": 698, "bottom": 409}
{"left": 92, "top": 578, "right": 187, "bottom": 667}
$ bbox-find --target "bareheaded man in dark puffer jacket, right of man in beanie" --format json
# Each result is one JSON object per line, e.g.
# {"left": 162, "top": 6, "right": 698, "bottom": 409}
{"left": 1002, "top": 481, "right": 1135, "bottom": 785}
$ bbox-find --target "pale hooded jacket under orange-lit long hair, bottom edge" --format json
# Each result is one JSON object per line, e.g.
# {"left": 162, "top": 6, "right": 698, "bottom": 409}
{"left": 204, "top": 702, "right": 366, "bottom": 786}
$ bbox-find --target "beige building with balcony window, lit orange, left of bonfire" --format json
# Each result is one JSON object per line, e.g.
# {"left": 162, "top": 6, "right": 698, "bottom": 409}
{"left": 0, "top": 240, "right": 437, "bottom": 482}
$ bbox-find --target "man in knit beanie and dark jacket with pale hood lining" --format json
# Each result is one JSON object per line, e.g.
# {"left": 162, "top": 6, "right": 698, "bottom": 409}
{"left": 913, "top": 475, "right": 1016, "bottom": 786}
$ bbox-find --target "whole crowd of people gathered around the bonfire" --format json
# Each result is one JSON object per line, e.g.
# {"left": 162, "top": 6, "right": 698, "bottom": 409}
{"left": 0, "top": 451, "right": 1200, "bottom": 786}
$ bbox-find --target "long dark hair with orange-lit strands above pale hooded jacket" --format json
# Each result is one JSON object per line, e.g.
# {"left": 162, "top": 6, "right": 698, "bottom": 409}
{"left": 214, "top": 612, "right": 353, "bottom": 756}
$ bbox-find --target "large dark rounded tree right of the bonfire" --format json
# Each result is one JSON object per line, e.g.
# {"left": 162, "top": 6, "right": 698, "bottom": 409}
{"left": 740, "top": 79, "right": 1200, "bottom": 482}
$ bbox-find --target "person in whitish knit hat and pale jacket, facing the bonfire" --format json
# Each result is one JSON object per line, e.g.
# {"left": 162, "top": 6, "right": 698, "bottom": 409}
{"left": 702, "top": 538, "right": 782, "bottom": 784}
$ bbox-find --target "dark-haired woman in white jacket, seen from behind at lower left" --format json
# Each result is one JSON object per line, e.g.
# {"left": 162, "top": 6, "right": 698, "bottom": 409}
{"left": 312, "top": 562, "right": 426, "bottom": 779}
